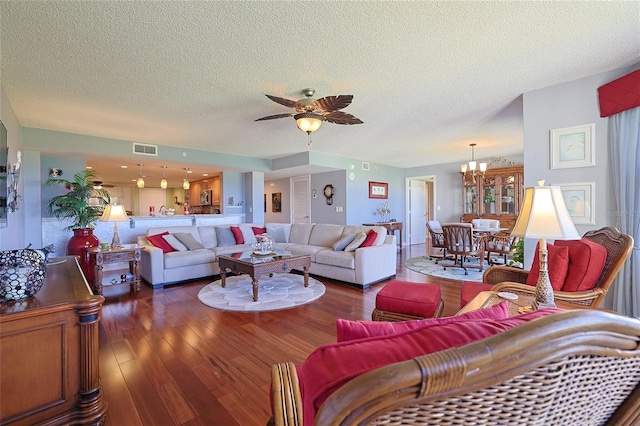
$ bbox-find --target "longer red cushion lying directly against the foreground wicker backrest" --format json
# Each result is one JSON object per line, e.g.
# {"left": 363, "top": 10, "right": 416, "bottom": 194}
{"left": 298, "top": 308, "right": 561, "bottom": 425}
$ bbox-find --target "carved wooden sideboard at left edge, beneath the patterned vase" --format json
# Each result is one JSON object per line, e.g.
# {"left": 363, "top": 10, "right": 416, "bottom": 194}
{"left": 0, "top": 256, "right": 107, "bottom": 425}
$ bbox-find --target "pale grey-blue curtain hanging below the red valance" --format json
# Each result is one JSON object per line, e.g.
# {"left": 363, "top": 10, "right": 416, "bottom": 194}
{"left": 609, "top": 107, "right": 640, "bottom": 318}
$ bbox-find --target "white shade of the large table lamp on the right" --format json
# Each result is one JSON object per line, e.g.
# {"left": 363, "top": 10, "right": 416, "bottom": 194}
{"left": 511, "top": 186, "right": 580, "bottom": 240}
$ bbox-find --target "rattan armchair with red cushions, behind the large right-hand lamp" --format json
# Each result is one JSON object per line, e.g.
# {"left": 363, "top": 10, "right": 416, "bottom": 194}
{"left": 460, "top": 227, "right": 633, "bottom": 307}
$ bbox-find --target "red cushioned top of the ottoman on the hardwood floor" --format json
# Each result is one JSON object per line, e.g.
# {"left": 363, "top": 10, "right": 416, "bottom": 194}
{"left": 376, "top": 280, "right": 441, "bottom": 318}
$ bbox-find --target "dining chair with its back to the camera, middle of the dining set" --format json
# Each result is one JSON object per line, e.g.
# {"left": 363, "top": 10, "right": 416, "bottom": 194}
{"left": 442, "top": 223, "right": 486, "bottom": 275}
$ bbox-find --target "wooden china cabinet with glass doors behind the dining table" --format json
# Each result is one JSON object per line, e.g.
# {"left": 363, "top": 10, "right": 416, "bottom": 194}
{"left": 460, "top": 166, "right": 524, "bottom": 229}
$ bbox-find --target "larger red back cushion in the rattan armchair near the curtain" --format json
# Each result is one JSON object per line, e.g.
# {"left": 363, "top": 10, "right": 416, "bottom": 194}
{"left": 554, "top": 238, "right": 607, "bottom": 291}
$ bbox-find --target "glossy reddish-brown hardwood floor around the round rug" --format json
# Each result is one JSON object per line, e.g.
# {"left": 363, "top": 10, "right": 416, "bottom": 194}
{"left": 100, "top": 245, "right": 461, "bottom": 426}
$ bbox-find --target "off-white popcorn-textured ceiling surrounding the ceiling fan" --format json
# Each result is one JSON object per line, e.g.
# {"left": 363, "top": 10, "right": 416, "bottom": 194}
{"left": 0, "top": 0, "right": 640, "bottom": 185}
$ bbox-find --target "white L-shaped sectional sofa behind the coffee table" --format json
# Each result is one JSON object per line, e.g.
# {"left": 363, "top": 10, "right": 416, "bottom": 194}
{"left": 138, "top": 223, "right": 397, "bottom": 288}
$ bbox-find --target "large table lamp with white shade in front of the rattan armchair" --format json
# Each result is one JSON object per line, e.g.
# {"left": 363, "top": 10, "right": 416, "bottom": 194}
{"left": 511, "top": 180, "right": 580, "bottom": 309}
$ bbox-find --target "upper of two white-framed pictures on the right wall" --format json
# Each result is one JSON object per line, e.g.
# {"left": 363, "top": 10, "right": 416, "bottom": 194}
{"left": 549, "top": 123, "right": 596, "bottom": 169}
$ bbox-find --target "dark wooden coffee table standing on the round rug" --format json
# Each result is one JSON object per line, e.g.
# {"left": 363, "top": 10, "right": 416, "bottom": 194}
{"left": 218, "top": 250, "right": 311, "bottom": 302}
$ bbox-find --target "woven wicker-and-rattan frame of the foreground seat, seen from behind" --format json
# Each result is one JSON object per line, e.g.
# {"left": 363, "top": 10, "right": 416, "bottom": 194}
{"left": 269, "top": 309, "right": 640, "bottom": 426}
